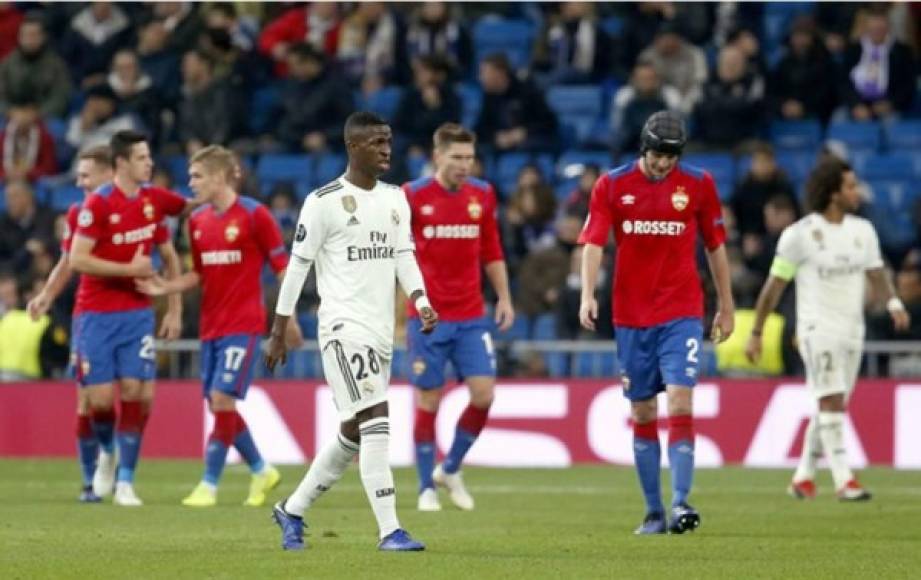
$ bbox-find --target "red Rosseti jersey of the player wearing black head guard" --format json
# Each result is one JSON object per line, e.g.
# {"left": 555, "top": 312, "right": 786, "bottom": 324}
{"left": 579, "top": 162, "right": 726, "bottom": 328}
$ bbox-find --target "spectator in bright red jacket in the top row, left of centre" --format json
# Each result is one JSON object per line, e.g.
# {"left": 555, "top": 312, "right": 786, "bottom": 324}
{"left": 259, "top": 2, "right": 341, "bottom": 77}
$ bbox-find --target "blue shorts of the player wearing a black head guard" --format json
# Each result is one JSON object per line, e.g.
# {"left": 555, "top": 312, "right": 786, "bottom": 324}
{"left": 614, "top": 318, "right": 704, "bottom": 401}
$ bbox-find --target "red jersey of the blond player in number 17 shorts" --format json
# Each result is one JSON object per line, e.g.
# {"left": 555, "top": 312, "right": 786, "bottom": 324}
{"left": 189, "top": 196, "right": 288, "bottom": 340}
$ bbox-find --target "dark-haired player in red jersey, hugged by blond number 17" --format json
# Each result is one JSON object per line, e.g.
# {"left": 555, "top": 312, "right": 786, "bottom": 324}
{"left": 69, "top": 131, "right": 194, "bottom": 506}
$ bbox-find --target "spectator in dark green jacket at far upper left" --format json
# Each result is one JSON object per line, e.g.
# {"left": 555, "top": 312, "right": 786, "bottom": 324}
{"left": 0, "top": 14, "right": 71, "bottom": 118}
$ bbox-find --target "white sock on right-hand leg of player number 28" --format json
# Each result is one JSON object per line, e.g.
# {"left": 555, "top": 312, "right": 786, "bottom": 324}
{"left": 358, "top": 417, "right": 400, "bottom": 539}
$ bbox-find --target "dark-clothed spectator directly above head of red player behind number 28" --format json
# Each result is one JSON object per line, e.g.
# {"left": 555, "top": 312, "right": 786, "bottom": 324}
{"left": 393, "top": 54, "right": 461, "bottom": 155}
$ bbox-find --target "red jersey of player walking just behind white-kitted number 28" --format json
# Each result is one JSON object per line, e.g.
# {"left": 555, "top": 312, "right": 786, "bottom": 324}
{"left": 403, "top": 177, "right": 504, "bottom": 321}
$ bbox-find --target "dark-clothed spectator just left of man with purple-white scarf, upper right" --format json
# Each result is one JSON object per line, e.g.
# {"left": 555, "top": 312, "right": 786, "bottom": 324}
{"left": 768, "top": 17, "right": 837, "bottom": 123}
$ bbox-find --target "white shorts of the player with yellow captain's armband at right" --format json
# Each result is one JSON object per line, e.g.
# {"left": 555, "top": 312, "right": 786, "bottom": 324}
{"left": 799, "top": 333, "right": 863, "bottom": 400}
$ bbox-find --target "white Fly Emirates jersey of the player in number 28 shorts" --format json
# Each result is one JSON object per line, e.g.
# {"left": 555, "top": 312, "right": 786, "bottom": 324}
{"left": 291, "top": 177, "right": 414, "bottom": 358}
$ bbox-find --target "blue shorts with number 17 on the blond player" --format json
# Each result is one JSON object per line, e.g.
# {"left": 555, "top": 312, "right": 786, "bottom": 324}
{"left": 201, "top": 334, "right": 259, "bottom": 399}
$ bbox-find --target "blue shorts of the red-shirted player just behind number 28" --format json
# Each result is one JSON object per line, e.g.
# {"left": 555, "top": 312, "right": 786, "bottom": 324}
{"left": 406, "top": 317, "right": 496, "bottom": 390}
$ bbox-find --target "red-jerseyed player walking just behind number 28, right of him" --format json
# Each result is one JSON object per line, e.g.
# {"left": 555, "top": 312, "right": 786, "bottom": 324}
{"left": 403, "top": 123, "right": 515, "bottom": 511}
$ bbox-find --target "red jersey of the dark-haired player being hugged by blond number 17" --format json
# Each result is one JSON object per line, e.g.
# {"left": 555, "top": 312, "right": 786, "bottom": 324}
{"left": 74, "top": 183, "right": 186, "bottom": 312}
